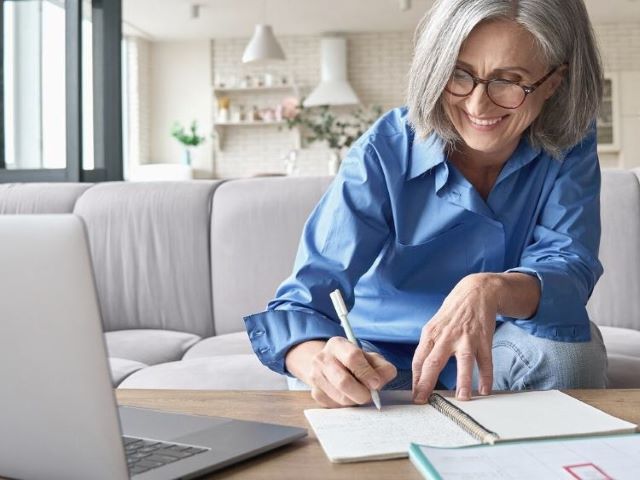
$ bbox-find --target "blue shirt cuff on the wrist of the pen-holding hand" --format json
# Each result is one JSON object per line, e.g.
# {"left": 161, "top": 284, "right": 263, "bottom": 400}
{"left": 244, "top": 310, "right": 344, "bottom": 375}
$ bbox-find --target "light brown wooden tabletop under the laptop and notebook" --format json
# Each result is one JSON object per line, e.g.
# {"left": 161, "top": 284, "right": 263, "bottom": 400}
{"left": 116, "top": 389, "right": 640, "bottom": 480}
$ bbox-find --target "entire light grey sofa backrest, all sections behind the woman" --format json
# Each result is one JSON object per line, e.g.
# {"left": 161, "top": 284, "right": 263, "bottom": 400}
{"left": 0, "top": 169, "right": 640, "bottom": 336}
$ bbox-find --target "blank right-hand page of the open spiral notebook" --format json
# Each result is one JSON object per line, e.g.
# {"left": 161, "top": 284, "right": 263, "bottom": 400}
{"left": 447, "top": 390, "right": 636, "bottom": 440}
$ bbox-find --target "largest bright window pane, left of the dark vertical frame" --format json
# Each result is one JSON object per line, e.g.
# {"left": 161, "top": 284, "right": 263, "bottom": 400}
{"left": 4, "top": 0, "right": 66, "bottom": 169}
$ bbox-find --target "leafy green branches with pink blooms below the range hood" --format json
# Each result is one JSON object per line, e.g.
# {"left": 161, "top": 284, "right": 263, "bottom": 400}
{"left": 282, "top": 97, "right": 382, "bottom": 151}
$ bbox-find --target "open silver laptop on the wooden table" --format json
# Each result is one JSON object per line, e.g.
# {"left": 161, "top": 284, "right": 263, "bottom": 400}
{"left": 0, "top": 215, "right": 307, "bottom": 480}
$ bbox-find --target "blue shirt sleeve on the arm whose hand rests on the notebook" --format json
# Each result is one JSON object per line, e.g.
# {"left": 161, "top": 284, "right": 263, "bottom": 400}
{"left": 507, "top": 129, "right": 603, "bottom": 341}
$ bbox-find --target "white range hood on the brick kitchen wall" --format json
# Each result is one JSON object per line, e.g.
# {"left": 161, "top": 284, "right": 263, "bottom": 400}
{"left": 303, "top": 37, "right": 360, "bottom": 107}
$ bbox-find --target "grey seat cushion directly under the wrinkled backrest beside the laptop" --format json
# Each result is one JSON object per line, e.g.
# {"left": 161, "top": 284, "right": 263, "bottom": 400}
{"left": 105, "top": 329, "right": 200, "bottom": 365}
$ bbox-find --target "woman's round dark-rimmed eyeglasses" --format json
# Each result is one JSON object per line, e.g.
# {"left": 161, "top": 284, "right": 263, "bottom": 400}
{"left": 444, "top": 66, "right": 559, "bottom": 109}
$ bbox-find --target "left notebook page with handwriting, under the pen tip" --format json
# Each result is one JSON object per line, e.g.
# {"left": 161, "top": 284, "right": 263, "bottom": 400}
{"left": 304, "top": 392, "right": 480, "bottom": 463}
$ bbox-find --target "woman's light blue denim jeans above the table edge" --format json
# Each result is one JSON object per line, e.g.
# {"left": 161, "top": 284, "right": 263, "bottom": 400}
{"left": 287, "top": 322, "right": 607, "bottom": 390}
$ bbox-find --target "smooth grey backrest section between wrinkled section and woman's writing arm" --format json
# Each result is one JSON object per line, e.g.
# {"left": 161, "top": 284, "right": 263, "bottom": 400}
{"left": 211, "top": 177, "right": 332, "bottom": 335}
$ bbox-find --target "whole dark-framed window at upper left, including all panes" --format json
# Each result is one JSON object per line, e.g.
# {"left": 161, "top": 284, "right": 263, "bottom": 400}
{"left": 0, "top": 0, "right": 122, "bottom": 182}
